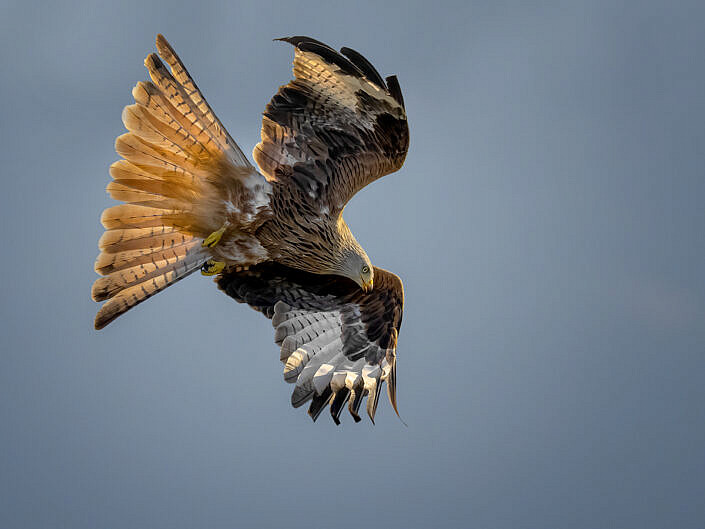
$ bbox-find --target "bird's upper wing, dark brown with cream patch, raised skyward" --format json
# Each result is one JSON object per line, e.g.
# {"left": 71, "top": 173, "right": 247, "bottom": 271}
{"left": 253, "top": 37, "right": 409, "bottom": 213}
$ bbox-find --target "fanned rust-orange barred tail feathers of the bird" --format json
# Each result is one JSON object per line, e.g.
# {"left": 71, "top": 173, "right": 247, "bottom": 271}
{"left": 92, "top": 35, "right": 251, "bottom": 329}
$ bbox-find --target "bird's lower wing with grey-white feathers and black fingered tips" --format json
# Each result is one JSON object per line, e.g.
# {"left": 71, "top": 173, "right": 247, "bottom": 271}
{"left": 218, "top": 262, "right": 404, "bottom": 424}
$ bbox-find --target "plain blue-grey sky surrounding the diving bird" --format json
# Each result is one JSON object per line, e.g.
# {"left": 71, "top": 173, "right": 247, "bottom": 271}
{"left": 0, "top": 0, "right": 705, "bottom": 529}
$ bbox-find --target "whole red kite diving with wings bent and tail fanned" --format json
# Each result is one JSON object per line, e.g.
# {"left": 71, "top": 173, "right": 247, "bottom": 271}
{"left": 92, "top": 35, "right": 409, "bottom": 424}
